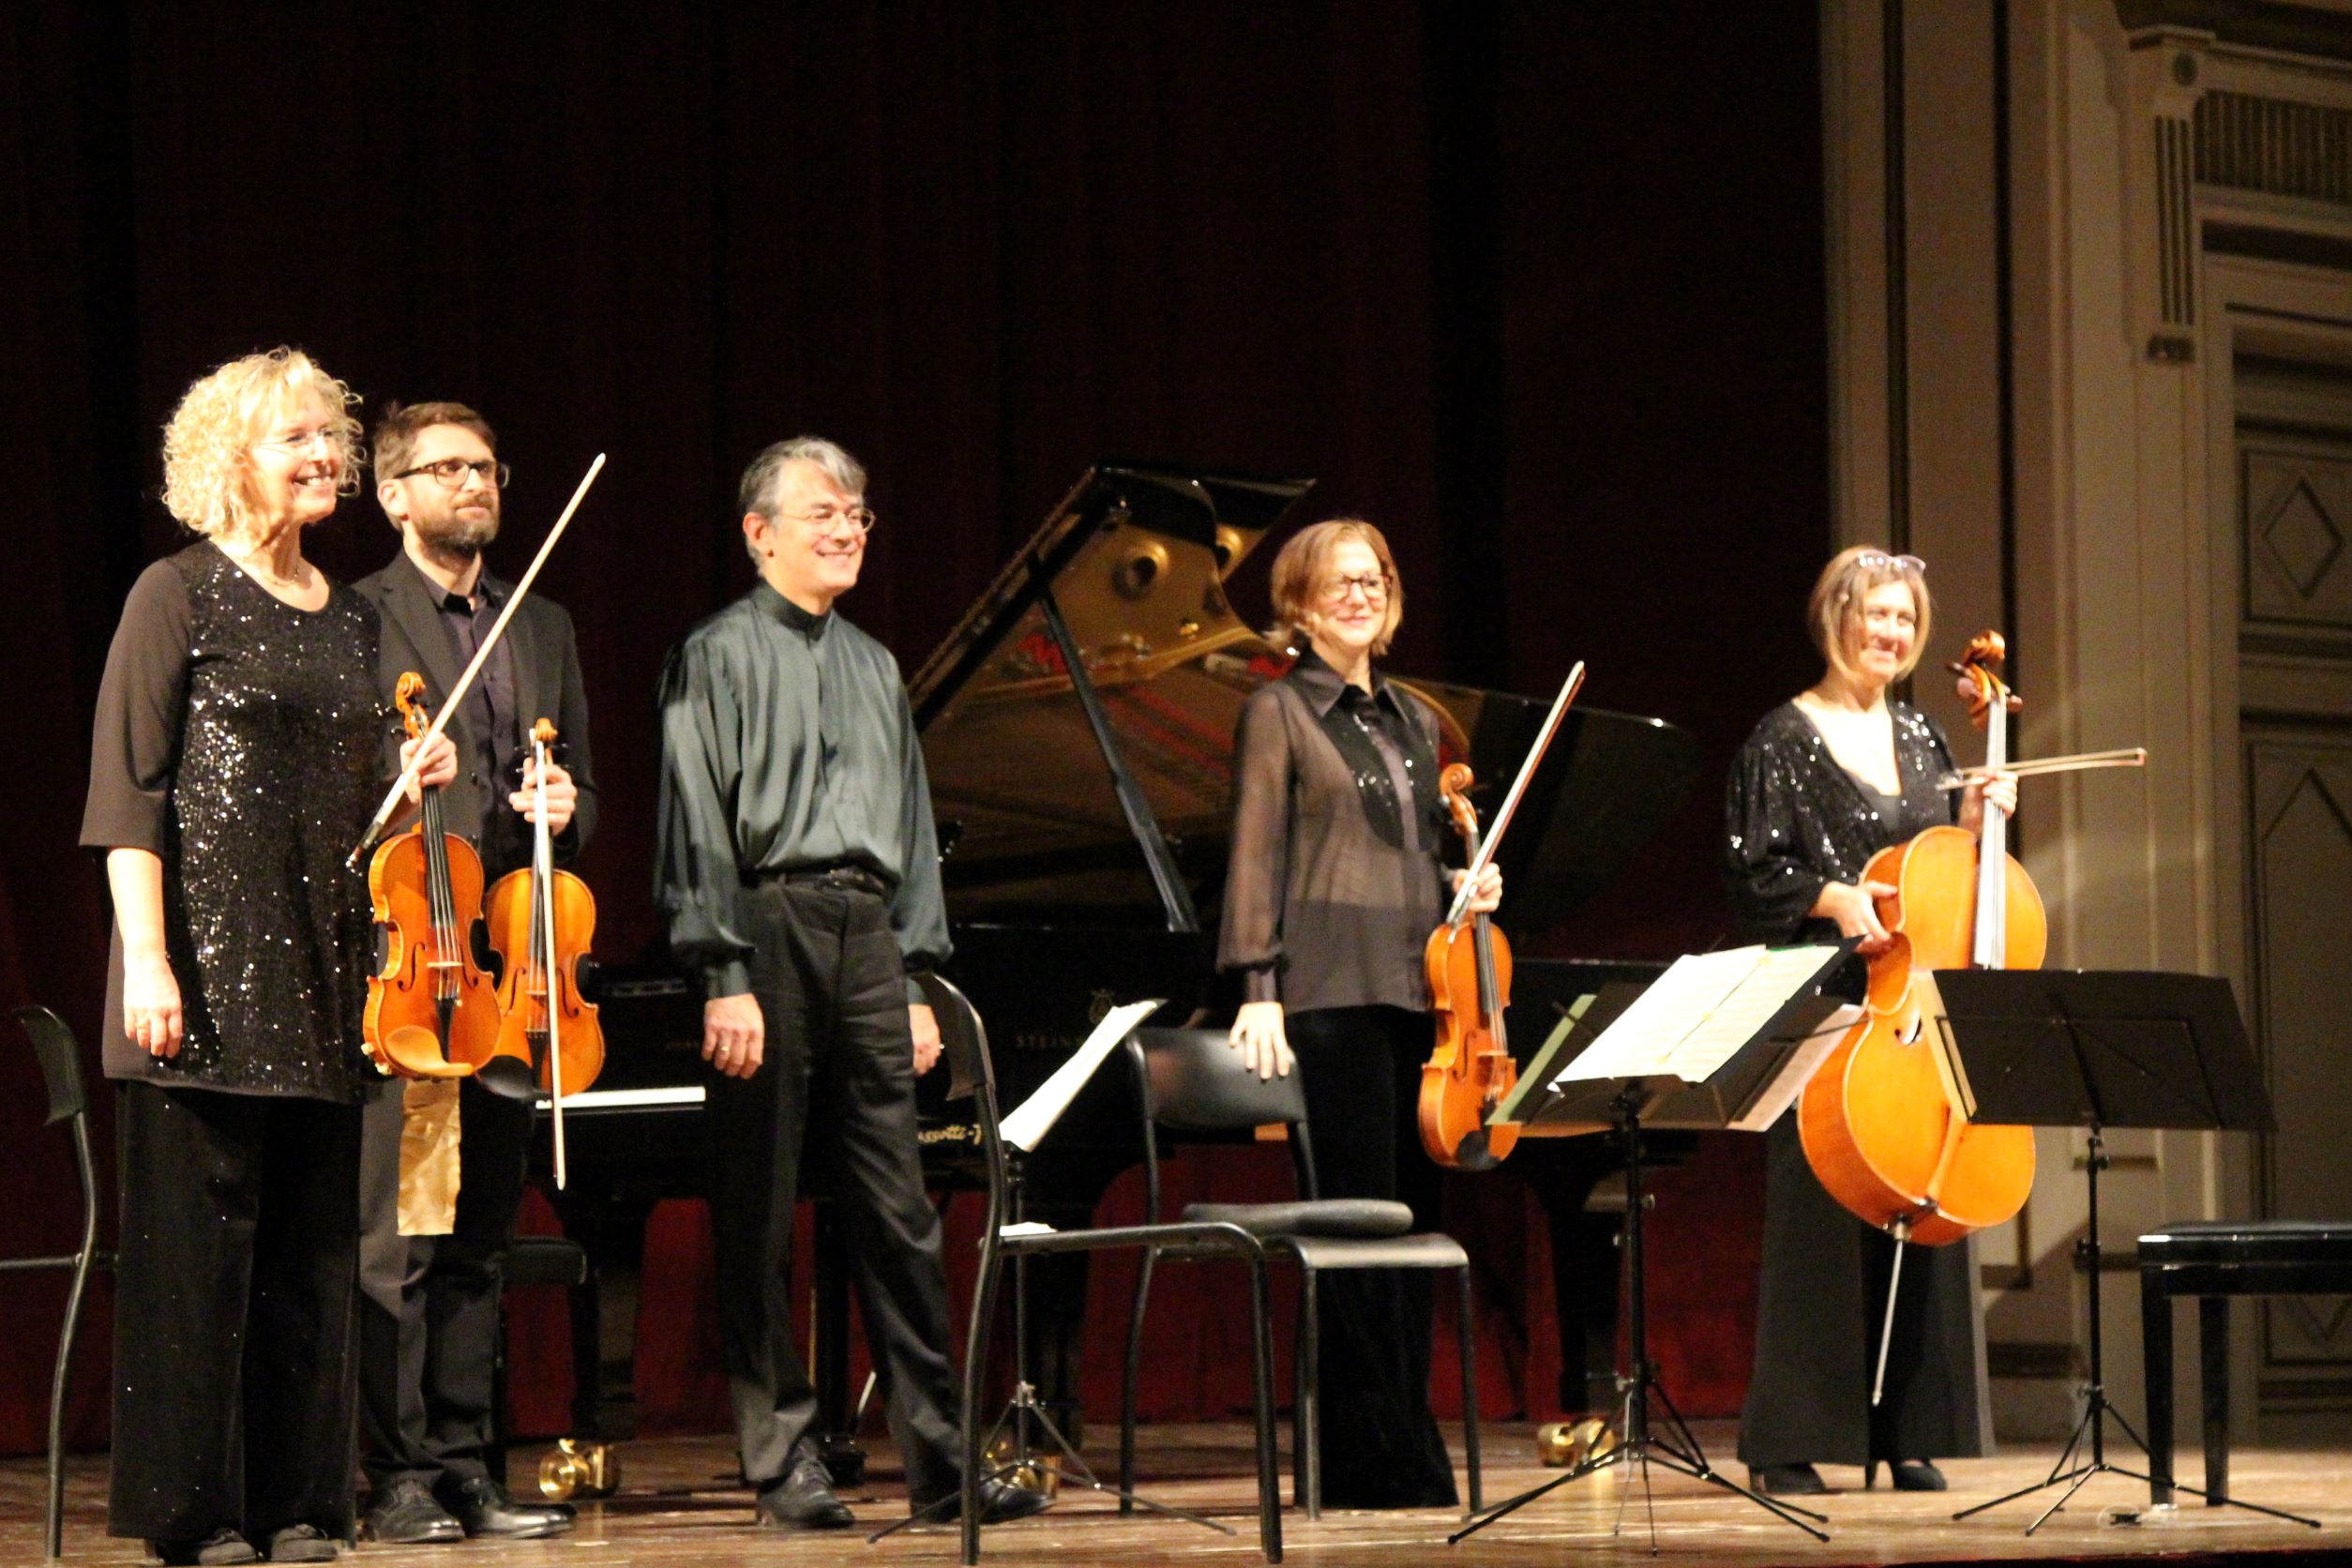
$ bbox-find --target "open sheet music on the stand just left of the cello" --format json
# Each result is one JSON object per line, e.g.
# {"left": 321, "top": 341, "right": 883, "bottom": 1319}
{"left": 1527, "top": 945, "right": 1858, "bottom": 1133}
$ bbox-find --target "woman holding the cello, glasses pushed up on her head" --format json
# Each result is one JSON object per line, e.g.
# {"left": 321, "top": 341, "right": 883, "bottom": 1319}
{"left": 1724, "top": 546, "right": 2015, "bottom": 1495}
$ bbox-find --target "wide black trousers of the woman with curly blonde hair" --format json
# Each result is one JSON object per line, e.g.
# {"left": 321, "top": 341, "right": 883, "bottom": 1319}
{"left": 106, "top": 1081, "right": 360, "bottom": 1545}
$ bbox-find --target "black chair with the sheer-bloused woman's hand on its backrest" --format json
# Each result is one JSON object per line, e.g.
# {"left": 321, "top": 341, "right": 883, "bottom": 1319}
{"left": 1120, "top": 1030, "right": 1485, "bottom": 1518}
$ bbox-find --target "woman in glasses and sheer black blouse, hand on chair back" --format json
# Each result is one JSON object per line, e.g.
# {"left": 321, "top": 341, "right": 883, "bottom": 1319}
{"left": 1218, "top": 520, "right": 1503, "bottom": 1509}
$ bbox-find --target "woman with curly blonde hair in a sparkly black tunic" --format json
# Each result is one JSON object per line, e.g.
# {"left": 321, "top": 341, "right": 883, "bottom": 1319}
{"left": 83, "top": 348, "right": 457, "bottom": 1563}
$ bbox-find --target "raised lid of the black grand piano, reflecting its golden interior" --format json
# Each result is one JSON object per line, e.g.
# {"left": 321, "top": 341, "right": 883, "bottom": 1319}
{"left": 911, "top": 463, "right": 1698, "bottom": 928}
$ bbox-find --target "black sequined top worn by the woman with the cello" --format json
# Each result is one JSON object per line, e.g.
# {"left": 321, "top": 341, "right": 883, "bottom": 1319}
{"left": 1724, "top": 701, "right": 1959, "bottom": 942}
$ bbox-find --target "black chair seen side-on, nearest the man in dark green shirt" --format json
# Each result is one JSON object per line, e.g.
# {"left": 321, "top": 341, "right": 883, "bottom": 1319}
{"left": 917, "top": 973, "right": 1282, "bottom": 1563}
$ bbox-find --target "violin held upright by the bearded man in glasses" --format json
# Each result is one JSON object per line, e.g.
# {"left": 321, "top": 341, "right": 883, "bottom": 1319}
{"left": 480, "top": 719, "right": 605, "bottom": 1100}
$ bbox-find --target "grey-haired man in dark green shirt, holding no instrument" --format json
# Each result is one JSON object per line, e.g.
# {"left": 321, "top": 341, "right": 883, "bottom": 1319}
{"left": 654, "top": 437, "right": 1047, "bottom": 1528}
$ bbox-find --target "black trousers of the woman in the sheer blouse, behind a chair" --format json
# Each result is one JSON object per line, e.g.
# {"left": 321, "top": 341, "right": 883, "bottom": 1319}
{"left": 1284, "top": 1006, "right": 1455, "bottom": 1509}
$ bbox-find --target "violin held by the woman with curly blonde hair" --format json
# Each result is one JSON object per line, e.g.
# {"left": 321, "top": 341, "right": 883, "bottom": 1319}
{"left": 360, "top": 670, "right": 499, "bottom": 1079}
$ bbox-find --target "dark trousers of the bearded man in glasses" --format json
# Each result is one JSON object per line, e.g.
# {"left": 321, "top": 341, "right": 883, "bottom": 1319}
{"left": 360, "top": 1079, "right": 532, "bottom": 1495}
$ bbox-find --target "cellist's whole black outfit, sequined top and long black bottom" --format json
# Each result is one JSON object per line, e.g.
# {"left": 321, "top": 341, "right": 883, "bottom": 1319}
{"left": 1724, "top": 703, "right": 1992, "bottom": 1465}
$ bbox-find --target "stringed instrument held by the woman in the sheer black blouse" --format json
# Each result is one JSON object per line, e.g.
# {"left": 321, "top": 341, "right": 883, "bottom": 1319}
{"left": 1421, "top": 761, "right": 1519, "bottom": 1170}
